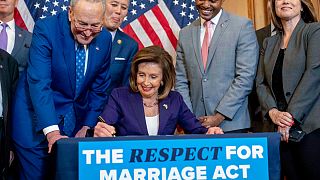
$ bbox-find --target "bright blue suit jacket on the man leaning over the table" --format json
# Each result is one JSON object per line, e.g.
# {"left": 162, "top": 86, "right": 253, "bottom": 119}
{"left": 13, "top": 13, "right": 111, "bottom": 147}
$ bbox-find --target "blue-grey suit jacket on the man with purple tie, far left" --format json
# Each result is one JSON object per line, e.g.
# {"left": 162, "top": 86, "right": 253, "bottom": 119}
{"left": 11, "top": 25, "right": 32, "bottom": 72}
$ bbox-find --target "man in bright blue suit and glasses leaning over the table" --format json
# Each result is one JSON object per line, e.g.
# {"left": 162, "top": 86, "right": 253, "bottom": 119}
{"left": 13, "top": 0, "right": 112, "bottom": 179}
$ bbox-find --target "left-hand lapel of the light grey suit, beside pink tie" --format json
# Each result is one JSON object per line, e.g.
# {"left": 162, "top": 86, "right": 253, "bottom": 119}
{"left": 191, "top": 18, "right": 204, "bottom": 74}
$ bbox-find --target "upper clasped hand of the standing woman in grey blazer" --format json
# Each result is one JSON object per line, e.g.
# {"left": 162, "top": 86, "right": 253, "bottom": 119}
{"left": 269, "top": 108, "right": 294, "bottom": 128}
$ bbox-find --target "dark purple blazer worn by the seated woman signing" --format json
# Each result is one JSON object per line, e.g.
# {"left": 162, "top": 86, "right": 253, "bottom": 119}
{"left": 101, "top": 87, "right": 207, "bottom": 136}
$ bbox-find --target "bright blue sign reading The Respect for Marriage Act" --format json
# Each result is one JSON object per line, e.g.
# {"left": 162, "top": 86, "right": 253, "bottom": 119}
{"left": 78, "top": 136, "right": 269, "bottom": 180}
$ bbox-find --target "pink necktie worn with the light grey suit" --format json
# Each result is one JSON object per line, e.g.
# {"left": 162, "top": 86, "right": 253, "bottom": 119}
{"left": 201, "top": 21, "right": 212, "bottom": 69}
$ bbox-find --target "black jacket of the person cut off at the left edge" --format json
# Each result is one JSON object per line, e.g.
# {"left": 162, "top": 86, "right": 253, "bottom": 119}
{"left": 0, "top": 49, "right": 19, "bottom": 177}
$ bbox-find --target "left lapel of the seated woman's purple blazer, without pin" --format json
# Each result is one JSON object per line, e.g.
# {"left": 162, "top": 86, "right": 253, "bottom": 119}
{"left": 128, "top": 93, "right": 149, "bottom": 135}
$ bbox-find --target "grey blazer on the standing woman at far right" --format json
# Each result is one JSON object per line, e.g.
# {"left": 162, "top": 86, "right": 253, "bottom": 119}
{"left": 256, "top": 20, "right": 320, "bottom": 133}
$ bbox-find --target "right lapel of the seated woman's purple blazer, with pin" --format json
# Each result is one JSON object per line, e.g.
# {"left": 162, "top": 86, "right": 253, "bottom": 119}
{"left": 158, "top": 98, "right": 170, "bottom": 135}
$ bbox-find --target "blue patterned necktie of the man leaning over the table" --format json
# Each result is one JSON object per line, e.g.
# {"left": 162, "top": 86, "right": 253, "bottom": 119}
{"left": 63, "top": 45, "right": 86, "bottom": 136}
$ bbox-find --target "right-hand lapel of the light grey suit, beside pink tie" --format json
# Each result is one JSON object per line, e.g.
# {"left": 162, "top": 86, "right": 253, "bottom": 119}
{"left": 206, "top": 11, "right": 229, "bottom": 72}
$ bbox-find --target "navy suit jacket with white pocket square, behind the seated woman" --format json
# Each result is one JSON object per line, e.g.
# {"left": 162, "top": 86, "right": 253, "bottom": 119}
{"left": 107, "top": 30, "right": 138, "bottom": 95}
